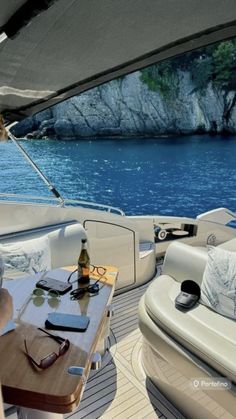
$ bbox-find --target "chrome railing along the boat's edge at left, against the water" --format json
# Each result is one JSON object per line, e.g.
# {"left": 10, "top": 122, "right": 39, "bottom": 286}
{"left": 0, "top": 193, "right": 125, "bottom": 216}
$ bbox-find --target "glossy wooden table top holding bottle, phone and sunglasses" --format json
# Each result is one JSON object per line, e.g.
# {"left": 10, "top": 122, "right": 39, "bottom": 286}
{"left": 0, "top": 266, "right": 118, "bottom": 413}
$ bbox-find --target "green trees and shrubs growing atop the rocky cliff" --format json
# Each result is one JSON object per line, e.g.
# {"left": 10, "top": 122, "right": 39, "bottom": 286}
{"left": 141, "top": 39, "right": 236, "bottom": 100}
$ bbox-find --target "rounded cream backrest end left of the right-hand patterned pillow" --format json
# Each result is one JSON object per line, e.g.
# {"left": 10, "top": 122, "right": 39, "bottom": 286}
{"left": 163, "top": 241, "right": 207, "bottom": 285}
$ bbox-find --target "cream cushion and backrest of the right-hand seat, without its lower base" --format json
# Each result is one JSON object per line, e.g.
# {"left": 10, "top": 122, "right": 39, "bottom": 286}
{"left": 139, "top": 238, "right": 236, "bottom": 382}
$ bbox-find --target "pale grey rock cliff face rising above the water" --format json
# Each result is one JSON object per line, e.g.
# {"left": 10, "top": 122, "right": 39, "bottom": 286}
{"left": 15, "top": 72, "right": 236, "bottom": 140}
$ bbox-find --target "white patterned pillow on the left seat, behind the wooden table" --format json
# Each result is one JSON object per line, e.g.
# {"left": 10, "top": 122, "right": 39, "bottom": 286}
{"left": 0, "top": 235, "right": 51, "bottom": 275}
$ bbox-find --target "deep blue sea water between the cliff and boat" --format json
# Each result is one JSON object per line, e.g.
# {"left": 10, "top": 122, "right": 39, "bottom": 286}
{"left": 0, "top": 136, "right": 236, "bottom": 217}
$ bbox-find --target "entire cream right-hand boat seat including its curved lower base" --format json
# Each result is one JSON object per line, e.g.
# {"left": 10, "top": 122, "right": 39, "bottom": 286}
{"left": 139, "top": 239, "right": 236, "bottom": 419}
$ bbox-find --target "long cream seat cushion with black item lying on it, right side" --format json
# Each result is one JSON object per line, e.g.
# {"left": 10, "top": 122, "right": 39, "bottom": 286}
{"left": 145, "top": 275, "right": 236, "bottom": 382}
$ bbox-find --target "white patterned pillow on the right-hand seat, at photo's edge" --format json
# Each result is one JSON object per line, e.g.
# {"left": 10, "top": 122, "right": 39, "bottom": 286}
{"left": 200, "top": 246, "right": 236, "bottom": 319}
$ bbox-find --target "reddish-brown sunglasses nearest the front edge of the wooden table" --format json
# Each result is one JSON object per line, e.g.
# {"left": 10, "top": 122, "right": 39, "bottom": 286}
{"left": 24, "top": 327, "right": 70, "bottom": 370}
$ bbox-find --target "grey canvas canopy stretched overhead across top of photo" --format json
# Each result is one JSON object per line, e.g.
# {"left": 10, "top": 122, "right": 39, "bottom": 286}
{"left": 0, "top": 0, "right": 236, "bottom": 121}
